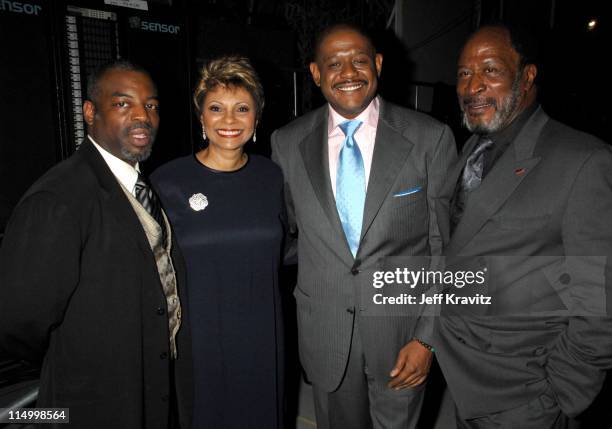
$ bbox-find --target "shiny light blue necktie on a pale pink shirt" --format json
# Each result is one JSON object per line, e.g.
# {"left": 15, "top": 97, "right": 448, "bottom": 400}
{"left": 336, "top": 121, "right": 366, "bottom": 256}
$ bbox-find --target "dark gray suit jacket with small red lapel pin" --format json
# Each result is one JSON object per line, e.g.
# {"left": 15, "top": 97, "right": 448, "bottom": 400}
{"left": 434, "top": 109, "right": 612, "bottom": 418}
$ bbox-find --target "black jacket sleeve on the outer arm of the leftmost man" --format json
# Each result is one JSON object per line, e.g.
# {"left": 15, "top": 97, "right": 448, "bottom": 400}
{"left": 0, "top": 192, "right": 81, "bottom": 362}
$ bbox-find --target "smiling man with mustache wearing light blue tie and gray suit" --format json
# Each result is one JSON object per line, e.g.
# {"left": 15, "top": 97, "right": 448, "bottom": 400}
{"left": 272, "top": 25, "right": 456, "bottom": 429}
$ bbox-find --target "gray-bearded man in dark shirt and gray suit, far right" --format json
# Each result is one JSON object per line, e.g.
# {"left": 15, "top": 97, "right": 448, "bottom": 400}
{"left": 434, "top": 26, "right": 612, "bottom": 429}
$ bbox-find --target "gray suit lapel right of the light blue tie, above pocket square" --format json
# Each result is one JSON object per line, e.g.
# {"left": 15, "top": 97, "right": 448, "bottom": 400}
{"left": 361, "top": 105, "right": 414, "bottom": 240}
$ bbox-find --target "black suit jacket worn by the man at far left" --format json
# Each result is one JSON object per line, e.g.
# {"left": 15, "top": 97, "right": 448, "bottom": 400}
{"left": 0, "top": 141, "right": 192, "bottom": 429}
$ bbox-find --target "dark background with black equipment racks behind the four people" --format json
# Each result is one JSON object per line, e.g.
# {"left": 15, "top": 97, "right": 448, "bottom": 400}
{"left": 0, "top": 0, "right": 612, "bottom": 234}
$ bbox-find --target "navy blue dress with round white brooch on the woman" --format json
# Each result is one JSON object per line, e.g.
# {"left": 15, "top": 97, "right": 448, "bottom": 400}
{"left": 151, "top": 155, "right": 283, "bottom": 429}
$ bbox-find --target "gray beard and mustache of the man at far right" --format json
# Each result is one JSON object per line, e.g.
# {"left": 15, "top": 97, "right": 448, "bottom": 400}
{"left": 459, "top": 73, "right": 523, "bottom": 134}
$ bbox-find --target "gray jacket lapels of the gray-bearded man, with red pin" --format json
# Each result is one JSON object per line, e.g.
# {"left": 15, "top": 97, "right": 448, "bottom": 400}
{"left": 446, "top": 109, "right": 548, "bottom": 255}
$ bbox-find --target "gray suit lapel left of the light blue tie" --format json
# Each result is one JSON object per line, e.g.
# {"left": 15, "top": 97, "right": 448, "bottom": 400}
{"left": 300, "top": 107, "right": 353, "bottom": 260}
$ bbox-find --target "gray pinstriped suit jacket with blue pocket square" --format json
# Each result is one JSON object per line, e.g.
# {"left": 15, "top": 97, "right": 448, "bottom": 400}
{"left": 272, "top": 100, "right": 456, "bottom": 391}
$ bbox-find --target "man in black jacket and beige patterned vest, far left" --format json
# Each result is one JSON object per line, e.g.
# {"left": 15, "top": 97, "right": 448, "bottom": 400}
{"left": 0, "top": 62, "right": 191, "bottom": 429}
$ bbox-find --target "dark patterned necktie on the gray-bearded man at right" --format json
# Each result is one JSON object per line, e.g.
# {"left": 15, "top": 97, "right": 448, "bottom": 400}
{"left": 451, "top": 137, "right": 493, "bottom": 234}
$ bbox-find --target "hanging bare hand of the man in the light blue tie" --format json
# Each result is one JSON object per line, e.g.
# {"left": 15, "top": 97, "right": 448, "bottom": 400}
{"left": 388, "top": 340, "right": 433, "bottom": 390}
